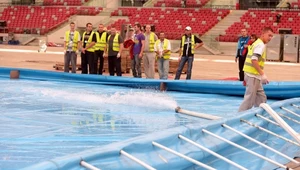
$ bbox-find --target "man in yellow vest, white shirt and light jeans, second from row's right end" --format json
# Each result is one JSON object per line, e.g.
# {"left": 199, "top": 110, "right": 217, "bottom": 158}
{"left": 154, "top": 32, "right": 171, "bottom": 80}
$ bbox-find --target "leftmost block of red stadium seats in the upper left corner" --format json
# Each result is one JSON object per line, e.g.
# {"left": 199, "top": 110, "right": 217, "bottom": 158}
{"left": 0, "top": 6, "right": 102, "bottom": 35}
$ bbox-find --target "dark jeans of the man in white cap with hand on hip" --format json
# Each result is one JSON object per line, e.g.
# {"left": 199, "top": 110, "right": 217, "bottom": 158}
{"left": 175, "top": 56, "right": 194, "bottom": 80}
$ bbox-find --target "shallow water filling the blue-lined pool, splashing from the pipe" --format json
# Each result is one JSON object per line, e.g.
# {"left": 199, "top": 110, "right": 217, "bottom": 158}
{"left": 0, "top": 79, "right": 262, "bottom": 170}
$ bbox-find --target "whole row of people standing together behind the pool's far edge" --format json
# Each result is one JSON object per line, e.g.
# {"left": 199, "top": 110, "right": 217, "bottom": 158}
{"left": 64, "top": 22, "right": 203, "bottom": 80}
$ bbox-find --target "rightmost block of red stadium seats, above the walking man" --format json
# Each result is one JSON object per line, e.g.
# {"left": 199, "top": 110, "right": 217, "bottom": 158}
{"left": 219, "top": 10, "right": 300, "bottom": 42}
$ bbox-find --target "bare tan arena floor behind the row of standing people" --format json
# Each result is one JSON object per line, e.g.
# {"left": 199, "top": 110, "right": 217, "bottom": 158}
{"left": 0, "top": 45, "right": 300, "bottom": 81}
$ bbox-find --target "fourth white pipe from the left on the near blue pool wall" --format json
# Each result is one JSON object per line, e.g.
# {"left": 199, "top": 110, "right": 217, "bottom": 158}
{"left": 178, "top": 135, "right": 247, "bottom": 170}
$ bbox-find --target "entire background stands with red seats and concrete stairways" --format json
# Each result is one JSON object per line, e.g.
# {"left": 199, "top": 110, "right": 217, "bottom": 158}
{"left": 0, "top": 0, "right": 300, "bottom": 53}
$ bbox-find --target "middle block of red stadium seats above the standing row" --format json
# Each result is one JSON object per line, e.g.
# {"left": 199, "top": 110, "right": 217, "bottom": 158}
{"left": 111, "top": 8, "right": 229, "bottom": 39}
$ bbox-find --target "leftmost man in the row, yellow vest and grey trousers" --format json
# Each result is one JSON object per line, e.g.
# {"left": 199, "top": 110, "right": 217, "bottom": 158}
{"left": 64, "top": 22, "right": 81, "bottom": 73}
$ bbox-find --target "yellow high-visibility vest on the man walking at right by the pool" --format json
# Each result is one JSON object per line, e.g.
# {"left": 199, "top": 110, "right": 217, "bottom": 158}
{"left": 243, "top": 39, "right": 266, "bottom": 75}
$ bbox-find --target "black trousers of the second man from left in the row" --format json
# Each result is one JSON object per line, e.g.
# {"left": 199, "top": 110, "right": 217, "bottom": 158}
{"left": 81, "top": 51, "right": 96, "bottom": 74}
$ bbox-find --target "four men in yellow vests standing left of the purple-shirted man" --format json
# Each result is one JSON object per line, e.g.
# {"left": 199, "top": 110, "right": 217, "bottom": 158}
{"left": 64, "top": 22, "right": 123, "bottom": 76}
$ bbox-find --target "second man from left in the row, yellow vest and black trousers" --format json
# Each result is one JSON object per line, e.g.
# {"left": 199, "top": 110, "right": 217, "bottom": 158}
{"left": 81, "top": 23, "right": 97, "bottom": 74}
